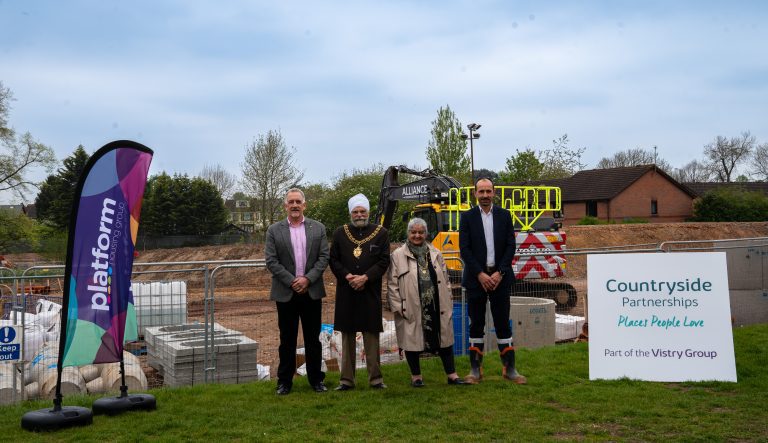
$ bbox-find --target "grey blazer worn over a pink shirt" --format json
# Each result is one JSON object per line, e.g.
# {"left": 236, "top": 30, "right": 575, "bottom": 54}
{"left": 264, "top": 217, "right": 330, "bottom": 302}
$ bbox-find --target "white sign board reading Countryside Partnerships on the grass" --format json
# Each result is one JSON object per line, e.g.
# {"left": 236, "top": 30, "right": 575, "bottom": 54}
{"left": 587, "top": 252, "right": 736, "bottom": 382}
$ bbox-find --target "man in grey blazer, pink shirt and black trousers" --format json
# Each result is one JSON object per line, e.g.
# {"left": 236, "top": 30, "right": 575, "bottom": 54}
{"left": 264, "top": 188, "right": 329, "bottom": 395}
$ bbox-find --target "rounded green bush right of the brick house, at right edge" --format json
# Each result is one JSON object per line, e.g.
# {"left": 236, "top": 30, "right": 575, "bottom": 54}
{"left": 691, "top": 188, "right": 768, "bottom": 222}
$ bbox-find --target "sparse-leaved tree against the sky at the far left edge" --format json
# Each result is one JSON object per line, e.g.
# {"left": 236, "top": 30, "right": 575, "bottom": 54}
{"left": 0, "top": 82, "right": 56, "bottom": 200}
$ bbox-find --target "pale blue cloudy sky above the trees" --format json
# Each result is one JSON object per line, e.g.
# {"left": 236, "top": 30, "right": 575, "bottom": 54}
{"left": 0, "top": 0, "right": 768, "bottom": 203}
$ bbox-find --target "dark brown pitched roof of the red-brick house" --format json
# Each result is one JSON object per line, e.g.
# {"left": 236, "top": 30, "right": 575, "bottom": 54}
{"left": 504, "top": 165, "right": 696, "bottom": 202}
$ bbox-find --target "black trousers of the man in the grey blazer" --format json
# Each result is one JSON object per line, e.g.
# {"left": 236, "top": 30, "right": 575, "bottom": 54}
{"left": 277, "top": 292, "right": 325, "bottom": 387}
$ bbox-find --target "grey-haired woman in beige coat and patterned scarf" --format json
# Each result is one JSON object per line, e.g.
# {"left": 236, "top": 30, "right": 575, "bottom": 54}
{"left": 387, "top": 218, "right": 465, "bottom": 388}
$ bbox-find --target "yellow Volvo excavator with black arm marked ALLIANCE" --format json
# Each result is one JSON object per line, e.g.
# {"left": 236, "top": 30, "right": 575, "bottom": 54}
{"left": 374, "top": 165, "right": 577, "bottom": 307}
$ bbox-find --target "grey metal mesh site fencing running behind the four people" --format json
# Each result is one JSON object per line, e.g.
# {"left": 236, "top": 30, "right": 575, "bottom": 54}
{"left": 0, "top": 238, "right": 768, "bottom": 403}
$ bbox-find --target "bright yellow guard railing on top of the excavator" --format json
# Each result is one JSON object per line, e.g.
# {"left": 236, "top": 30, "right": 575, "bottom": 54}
{"left": 448, "top": 186, "right": 562, "bottom": 232}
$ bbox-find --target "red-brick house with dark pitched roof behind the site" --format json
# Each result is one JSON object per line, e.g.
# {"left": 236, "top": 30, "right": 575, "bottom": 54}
{"left": 512, "top": 165, "right": 697, "bottom": 226}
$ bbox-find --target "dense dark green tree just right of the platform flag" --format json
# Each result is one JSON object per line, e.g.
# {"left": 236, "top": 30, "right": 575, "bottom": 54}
{"left": 139, "top": 172, "right": 229, "bottom": 236}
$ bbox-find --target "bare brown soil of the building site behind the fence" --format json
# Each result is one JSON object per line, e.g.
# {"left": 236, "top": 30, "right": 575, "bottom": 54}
{"left": 6, "top": 222, "right": 768, "bottom": 386}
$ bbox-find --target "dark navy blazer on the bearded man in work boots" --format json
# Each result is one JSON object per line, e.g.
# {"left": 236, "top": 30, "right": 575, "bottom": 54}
{"left": 459, "top": 205, "right": 515, "bottom": 290}
